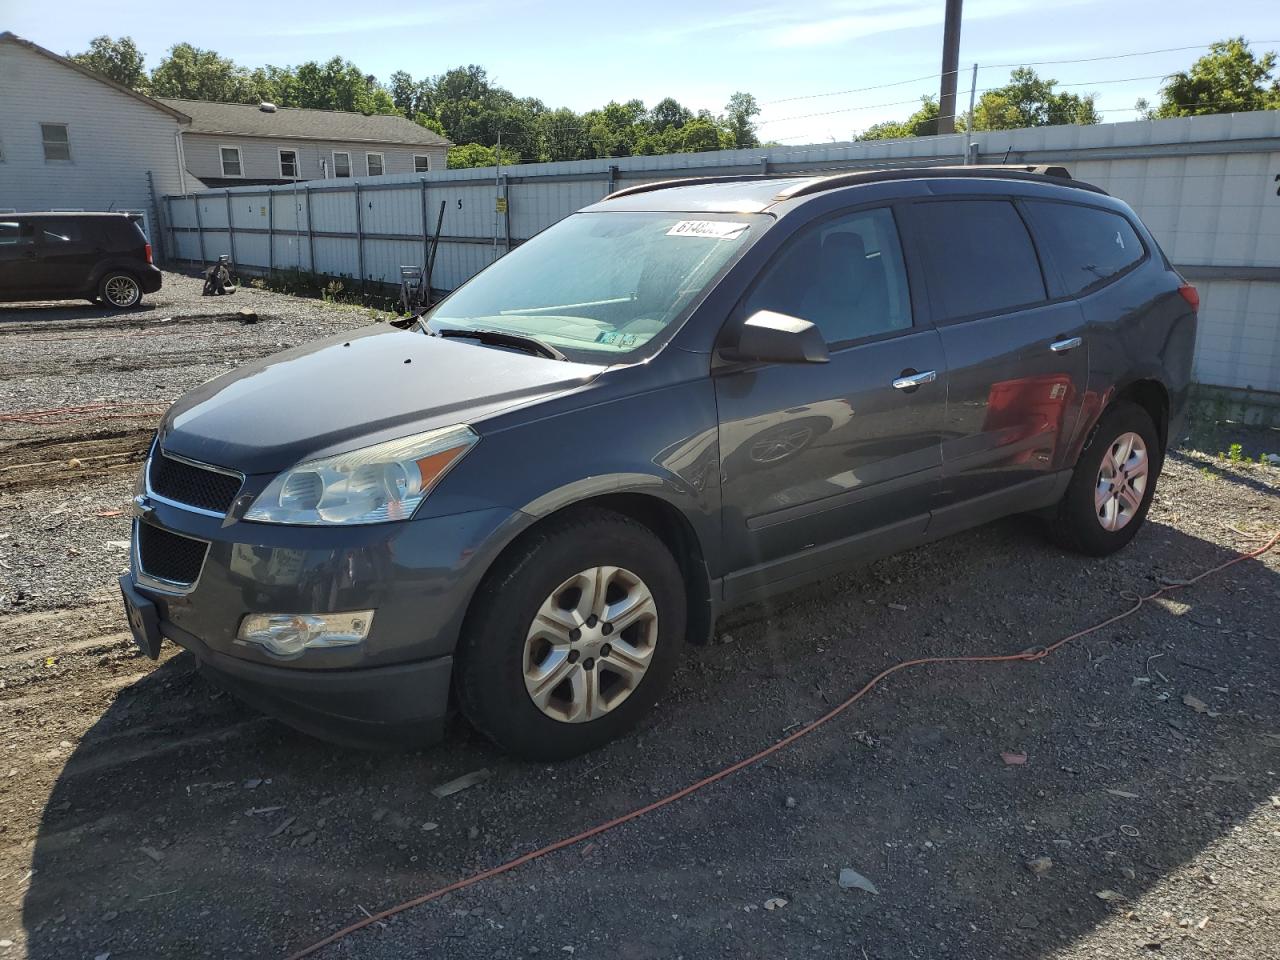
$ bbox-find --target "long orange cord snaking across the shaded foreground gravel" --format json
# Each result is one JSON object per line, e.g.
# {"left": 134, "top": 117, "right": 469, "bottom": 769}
{"left": 288, "top": 531, "right": 1280, "bottom": 960}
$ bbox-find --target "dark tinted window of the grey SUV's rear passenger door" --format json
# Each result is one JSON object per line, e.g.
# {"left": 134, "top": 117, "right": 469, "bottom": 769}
{"left": 911, "top": 200, "right": 1046, "bottom": 323}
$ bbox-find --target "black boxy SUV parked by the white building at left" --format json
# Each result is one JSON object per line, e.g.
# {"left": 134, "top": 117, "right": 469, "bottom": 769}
{"left": 0, "top": 214, "right": 160, "bottom": 310}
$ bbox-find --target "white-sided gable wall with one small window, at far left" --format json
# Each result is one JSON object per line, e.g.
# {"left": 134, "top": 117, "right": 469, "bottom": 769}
{"left": 0, "top": 42, "right": 183, "bottom": 210}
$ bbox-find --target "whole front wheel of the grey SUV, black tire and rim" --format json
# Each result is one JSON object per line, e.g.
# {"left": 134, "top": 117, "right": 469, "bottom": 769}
{"left": 454, "top": 509, "right": 686, "bottom": 760}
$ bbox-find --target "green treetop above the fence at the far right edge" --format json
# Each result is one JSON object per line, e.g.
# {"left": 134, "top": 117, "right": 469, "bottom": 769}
{"left": 1138, "top": 37, "right": 1280, "bottom": 118}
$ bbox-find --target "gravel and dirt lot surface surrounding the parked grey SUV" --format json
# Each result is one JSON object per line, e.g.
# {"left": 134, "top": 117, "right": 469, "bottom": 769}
{"left": 0, "top": 276, "right": 1280, "bottom": 960}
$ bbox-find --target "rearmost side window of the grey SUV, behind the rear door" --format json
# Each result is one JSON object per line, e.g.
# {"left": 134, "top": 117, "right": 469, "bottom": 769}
{"left": 1027, "top": 200, "right": 1147, "bottom": 294}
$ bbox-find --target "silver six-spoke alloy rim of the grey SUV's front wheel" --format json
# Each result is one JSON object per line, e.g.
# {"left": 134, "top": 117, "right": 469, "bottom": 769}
{"left": 524, "top": 567, "right": 658, "bottom": 723}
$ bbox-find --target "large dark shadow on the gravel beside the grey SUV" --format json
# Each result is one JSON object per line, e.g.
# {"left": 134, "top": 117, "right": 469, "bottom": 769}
{"left": 22, "top": 521, "right": 1280, "bottom": 960}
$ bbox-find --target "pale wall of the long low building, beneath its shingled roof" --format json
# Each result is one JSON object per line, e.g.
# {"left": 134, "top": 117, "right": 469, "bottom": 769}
{"left": 182, "top": 132, "right": 448, "bottom": 180}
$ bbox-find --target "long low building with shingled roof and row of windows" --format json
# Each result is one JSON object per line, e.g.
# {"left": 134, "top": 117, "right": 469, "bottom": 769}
{"left": 160, "top": 97, "right": 452, "bottom": 187}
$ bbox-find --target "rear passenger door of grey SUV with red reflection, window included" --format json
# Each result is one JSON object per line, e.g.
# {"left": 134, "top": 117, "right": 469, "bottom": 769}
{"left": 909, "top": 197, "right": 1089, "bottom": 534}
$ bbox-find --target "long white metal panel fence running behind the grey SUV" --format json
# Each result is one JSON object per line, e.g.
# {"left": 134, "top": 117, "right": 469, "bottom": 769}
{"left": 165, "top": 110, "right": 1280, "bottom": 392}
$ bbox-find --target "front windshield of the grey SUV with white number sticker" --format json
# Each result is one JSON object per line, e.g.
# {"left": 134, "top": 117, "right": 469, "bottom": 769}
{"left": 426, "top": 212, "right": 758, "bottom": 364}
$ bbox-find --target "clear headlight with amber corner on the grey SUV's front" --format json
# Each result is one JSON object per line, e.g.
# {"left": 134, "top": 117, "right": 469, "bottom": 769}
{"left": 244, "top": 425, "right": 479, "bottom": 524}
